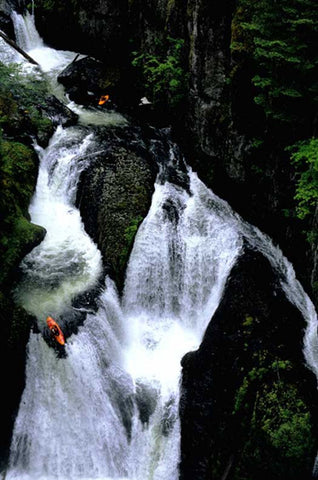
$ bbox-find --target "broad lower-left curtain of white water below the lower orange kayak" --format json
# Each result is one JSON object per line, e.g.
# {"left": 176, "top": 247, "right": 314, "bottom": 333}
{"left": 7, "top": 282, "right": 133, "bottom": 480}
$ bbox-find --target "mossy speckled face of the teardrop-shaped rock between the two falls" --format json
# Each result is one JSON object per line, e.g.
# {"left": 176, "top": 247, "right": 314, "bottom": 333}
{"left": 80, "top": 143, "right": 153, "bottom": 288}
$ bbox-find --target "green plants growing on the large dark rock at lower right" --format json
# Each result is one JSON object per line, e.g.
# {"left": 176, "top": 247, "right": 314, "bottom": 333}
{"left": 233, "top": 352, "right": 315, "bottom": 480}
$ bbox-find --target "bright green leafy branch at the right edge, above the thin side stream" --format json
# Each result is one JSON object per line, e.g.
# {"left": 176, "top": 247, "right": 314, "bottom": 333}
{"left": 289, "top": 138, "right": 318, "bottom": 219}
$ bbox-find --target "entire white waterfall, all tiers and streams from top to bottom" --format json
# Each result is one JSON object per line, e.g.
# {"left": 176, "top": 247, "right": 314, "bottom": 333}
{"left": 2, "top": 6, "right": 318, "bottom": 480}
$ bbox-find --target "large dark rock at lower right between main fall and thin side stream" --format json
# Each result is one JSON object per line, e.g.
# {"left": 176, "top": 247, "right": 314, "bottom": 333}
{"left": 180, "top": 250, "right": 318, "bottom": 480}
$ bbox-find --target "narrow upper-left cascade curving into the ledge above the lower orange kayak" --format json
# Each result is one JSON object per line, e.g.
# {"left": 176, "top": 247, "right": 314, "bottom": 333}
{"left": 17, "top": 127, "right": 102, "bottom": 321}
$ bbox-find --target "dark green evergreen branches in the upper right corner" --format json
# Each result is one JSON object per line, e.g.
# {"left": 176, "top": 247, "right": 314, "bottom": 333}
{"left": 231, "top": 0, "right": 318, "bottom": 122}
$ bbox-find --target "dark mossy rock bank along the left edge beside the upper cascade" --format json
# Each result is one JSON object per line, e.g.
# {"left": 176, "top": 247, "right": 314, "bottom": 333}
{"left": 0, "top": 63, "right": 53, "bottom": 284}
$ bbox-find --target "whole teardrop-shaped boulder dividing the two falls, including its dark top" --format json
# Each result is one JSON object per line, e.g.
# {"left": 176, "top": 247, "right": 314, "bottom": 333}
{"left": 77, "top": 127, "right": 158, "bottom": 289}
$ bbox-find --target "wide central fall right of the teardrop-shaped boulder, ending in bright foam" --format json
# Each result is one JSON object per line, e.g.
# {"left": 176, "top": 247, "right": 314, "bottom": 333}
{"left": 123, "top": 176, "right": 242, "bottom": 395}
